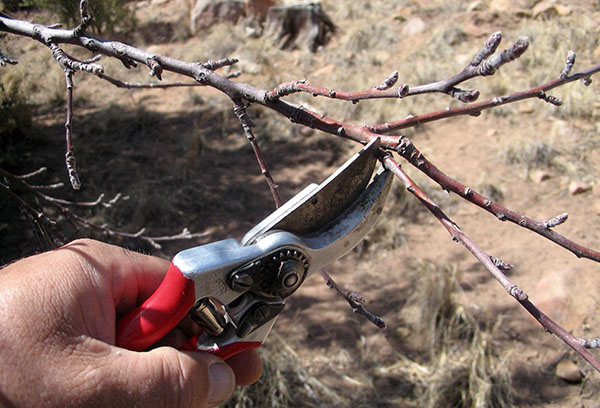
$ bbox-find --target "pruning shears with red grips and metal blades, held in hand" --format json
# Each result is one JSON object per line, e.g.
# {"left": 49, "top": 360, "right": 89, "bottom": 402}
{"left": 116, "top": 139, "right": 392, "bottom": 359}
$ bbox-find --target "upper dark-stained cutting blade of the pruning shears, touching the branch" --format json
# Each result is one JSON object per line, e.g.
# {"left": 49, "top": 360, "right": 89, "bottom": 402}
{"left": 241, "top": 138, "right": 379, "bottom": 245}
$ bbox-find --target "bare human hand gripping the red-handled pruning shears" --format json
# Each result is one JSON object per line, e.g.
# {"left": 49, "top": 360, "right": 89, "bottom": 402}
{"left": 0, "top": 240, "right": 262, "bottom": 408}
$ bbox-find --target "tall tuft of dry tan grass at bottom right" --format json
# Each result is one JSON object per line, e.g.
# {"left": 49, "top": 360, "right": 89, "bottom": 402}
{"left": 377, "top": 261, "right": 512, "bottom": 408}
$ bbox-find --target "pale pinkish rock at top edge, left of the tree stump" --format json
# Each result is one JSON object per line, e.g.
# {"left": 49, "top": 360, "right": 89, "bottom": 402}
{"left": 190, "top": 0, "right": 244, "bottom": 33}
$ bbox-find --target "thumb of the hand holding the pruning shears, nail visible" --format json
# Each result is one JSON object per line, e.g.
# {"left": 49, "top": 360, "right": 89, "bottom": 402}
{"left": 112, "top": 347, "right": 235, "bottom": 408}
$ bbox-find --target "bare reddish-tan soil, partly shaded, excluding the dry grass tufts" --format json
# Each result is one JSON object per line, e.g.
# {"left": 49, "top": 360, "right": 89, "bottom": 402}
{"left": 0, "top": 0, "right": 600, "bottom": 407}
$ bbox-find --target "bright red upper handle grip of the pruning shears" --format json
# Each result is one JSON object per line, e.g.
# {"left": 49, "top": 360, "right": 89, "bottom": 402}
{"left": 116, "top": 263, "right": 196, "bottom": 351}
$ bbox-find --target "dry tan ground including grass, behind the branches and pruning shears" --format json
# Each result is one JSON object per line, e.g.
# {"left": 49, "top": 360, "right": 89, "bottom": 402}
{"left": 0, "top": 0, "right": 600, "bottom": 407}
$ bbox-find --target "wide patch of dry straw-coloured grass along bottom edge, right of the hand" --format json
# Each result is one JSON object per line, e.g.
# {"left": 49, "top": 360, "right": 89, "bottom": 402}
{"left": 223, "top": 261, "right": 512, "bottom": 408}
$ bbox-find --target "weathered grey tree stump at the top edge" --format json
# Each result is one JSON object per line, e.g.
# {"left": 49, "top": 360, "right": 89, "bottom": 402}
{"left": 264, "top": 3, "right": 336, "bottom": 52}
